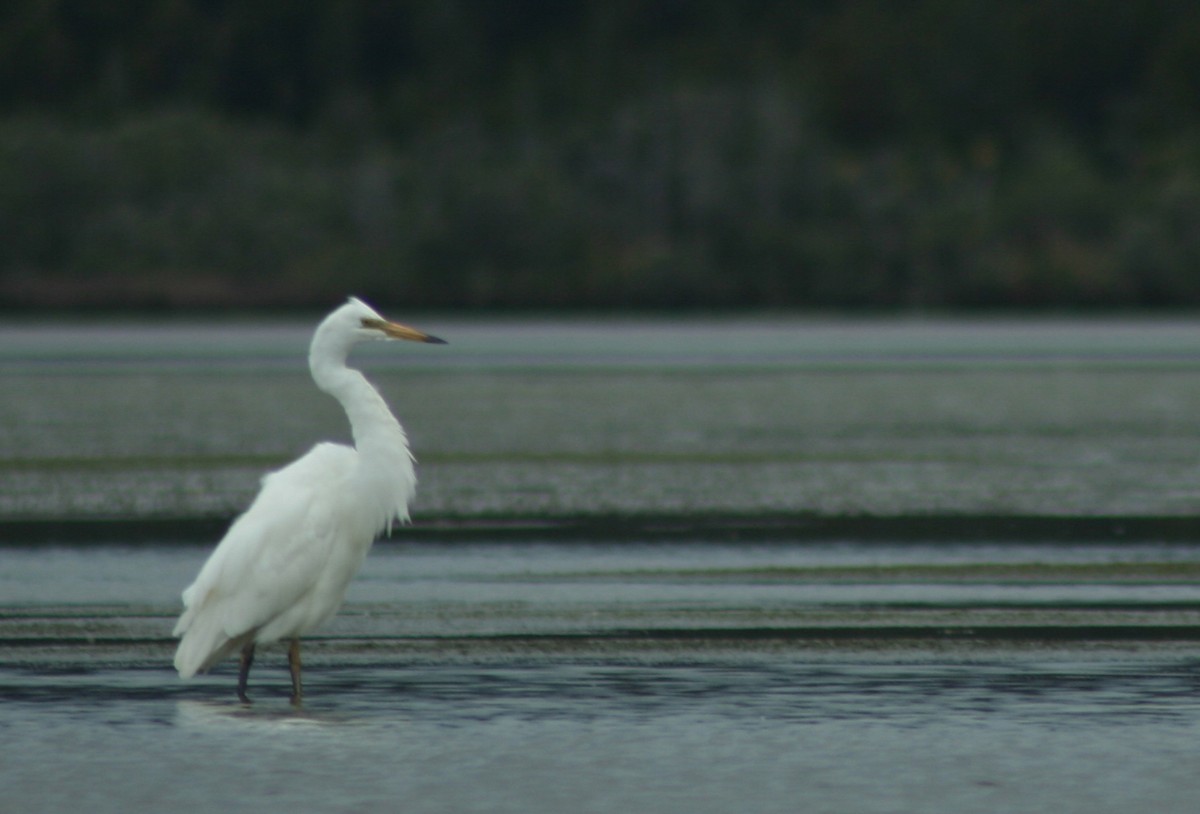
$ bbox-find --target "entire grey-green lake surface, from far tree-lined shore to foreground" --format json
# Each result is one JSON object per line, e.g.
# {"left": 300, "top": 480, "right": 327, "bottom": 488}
{"left": 0, "top": 313, "right": 1200, "bottom": 814}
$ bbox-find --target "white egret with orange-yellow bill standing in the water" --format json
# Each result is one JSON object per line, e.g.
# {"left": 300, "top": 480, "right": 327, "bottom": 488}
{"left": 174, "top": 297, "right": 445, "bottom": 704}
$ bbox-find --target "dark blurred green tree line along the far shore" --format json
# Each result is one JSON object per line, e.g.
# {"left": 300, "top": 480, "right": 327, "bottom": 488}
{"left": 0, "top": 0, "right": 1200, "bottom": 309}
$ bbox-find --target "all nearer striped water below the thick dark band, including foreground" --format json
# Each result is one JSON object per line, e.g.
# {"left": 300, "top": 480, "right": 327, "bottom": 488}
{"left": 0, "top": 538, "right": 1200, "bottom": 813}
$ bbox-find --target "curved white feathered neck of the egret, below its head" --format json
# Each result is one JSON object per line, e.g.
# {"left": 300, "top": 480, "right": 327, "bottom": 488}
{"left": 308, "top": 331, "right": 416, "bottom": 531}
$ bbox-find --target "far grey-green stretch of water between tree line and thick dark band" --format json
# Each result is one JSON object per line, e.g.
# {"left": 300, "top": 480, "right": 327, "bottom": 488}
{"left": 7, "top": 318, "right": 1200, "bottom": 522}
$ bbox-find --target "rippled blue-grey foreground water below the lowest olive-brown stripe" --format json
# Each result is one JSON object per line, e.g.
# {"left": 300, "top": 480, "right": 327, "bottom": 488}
{"left": 7, "top": 653, "right": 1200, "bottom": 814}
